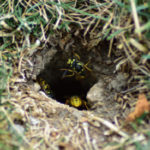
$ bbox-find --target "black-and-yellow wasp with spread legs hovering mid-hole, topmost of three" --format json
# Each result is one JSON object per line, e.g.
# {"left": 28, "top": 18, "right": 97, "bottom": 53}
{"left": 60, "top": 53, "right": 92, "bottom": 79}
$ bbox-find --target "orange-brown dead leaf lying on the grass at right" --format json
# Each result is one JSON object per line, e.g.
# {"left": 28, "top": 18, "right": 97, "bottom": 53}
{"left": 126, "top": 94, "right": 150, "bottom": 122}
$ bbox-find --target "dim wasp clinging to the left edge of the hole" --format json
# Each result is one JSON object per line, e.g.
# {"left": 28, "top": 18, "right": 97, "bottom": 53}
{"left": 38, "top": 77, "right": 54, "bottom": 98}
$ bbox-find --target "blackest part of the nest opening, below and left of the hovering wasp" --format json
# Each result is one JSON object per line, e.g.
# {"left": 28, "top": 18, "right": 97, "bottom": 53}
{"left": 38, "top": 52, "right": 96, "bottom": 109}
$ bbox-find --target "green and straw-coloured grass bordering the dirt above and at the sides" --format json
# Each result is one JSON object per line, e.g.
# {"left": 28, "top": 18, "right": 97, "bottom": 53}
{"left": 0, "top": 0, "right": 150, "bottom": 150}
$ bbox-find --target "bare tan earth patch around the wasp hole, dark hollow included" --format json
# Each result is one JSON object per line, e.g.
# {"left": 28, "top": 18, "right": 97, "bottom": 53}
{"left": 10, "top": 30, "right": 132, "bottom": 150}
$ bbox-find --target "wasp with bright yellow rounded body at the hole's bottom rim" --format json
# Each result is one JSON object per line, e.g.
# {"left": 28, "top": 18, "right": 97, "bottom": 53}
{"left": 66, "top": 96, "right": 88, "bottom": 110}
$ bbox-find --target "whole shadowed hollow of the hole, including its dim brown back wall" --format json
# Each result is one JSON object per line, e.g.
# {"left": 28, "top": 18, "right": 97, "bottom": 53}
{"left": 35, "top": 38, "right": 113, "bottom": 109}
